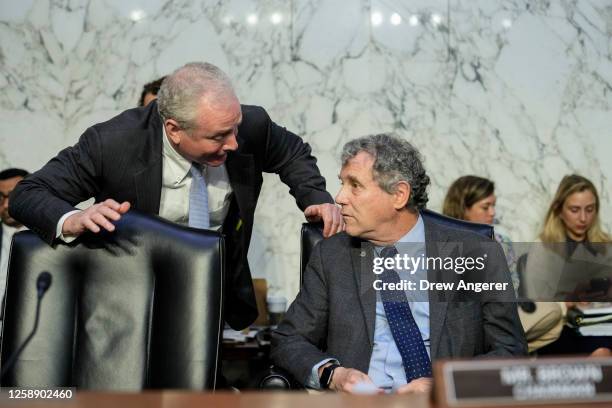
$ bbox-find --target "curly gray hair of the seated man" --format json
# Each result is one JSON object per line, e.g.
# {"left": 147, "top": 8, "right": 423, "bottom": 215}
{"left": 341, "top": 134, "right": 429, "bottom": 210}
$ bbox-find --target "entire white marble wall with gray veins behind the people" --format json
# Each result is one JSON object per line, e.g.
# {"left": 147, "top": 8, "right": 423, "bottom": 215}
{"left": 0, "top": 0, "right": 612, "bottom": 299}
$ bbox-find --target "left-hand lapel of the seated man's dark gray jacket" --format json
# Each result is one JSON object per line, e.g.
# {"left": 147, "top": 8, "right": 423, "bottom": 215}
{"left": 351, "top": 238, "right": 376, "bottom": 346}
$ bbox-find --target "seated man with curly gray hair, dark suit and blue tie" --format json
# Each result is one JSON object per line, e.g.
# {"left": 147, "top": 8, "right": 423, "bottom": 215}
{"left": 272, "top": 135, "right": 527, "bottom": 392}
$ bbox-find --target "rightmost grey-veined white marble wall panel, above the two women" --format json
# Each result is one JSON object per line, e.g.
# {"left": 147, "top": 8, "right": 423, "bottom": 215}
{"left": 449, "top": 0, "right": 612, "bottom": 240}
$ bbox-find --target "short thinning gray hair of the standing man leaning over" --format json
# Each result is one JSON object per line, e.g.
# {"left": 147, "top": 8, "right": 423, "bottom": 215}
{"left": 157, "top": 62, "right": 235, "bottom": 129}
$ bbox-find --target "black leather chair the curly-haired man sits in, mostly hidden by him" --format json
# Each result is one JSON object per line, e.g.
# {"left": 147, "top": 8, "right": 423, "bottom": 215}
{"left": 259, "top": 209, "right": 493, "bottom": 390}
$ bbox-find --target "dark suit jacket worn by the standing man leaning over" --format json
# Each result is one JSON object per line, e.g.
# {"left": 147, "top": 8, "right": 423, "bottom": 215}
{"left": 10, "top": 103, "right": 333, "bottom": 329}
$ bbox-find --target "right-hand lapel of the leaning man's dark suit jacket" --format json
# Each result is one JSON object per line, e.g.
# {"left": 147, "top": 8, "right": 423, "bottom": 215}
{"left": 225, "top": 152, "right": 255, "bottom": 217}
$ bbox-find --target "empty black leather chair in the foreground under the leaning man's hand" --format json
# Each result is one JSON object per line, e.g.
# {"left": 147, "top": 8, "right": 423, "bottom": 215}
{"left": 1, "top": 211, "right": 224, "bottom": 391}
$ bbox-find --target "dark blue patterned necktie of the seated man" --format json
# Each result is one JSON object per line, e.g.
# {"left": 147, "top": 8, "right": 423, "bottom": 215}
{"left": 380, "top": 247, "right": 431, "bottom": 382}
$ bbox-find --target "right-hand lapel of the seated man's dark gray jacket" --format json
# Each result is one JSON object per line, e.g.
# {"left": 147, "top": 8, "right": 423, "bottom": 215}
{"left": 423, "top": 216, "right": 456, "bottom": 360}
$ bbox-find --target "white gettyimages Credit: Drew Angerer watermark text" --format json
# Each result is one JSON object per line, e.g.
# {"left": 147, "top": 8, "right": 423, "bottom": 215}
{"left": 372, "top": 254, "right": 511, "bottom": 293}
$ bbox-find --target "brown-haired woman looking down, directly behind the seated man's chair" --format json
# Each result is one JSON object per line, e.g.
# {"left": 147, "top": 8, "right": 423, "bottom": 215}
{"left": 442, "top": 175, "right": 563, "bottom": 352}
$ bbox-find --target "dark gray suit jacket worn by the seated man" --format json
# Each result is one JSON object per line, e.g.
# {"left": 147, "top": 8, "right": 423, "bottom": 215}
{"left": 272, "top": 217, "right": 527, "bottom": 383}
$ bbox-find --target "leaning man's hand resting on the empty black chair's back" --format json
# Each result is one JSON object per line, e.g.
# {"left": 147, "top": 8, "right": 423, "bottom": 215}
{"left": 62, "top": 198, "right": 130, "bottom": 236}
